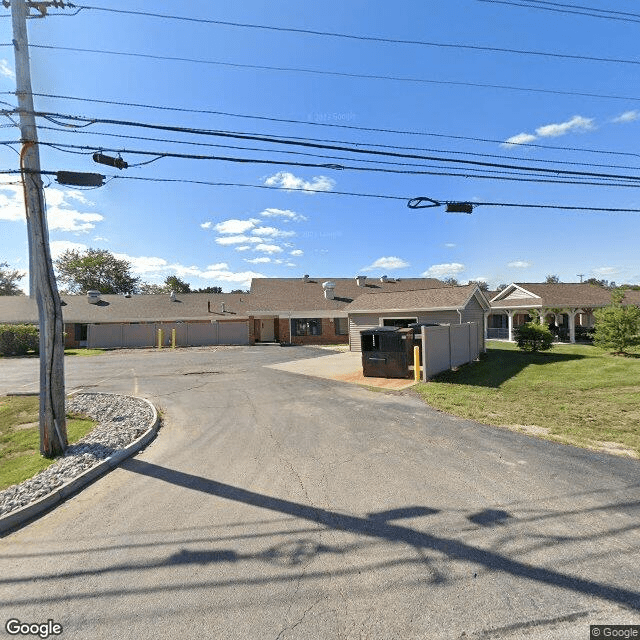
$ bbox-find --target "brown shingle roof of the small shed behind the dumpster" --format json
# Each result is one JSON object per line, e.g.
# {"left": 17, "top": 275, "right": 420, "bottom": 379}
{"left": 345, "top": 284, "right": 488, "bottom": 313}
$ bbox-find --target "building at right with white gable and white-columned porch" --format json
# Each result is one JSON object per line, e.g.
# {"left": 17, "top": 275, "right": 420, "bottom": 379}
{"left": 485, "top": 283, "right": 624, "bottom": 342}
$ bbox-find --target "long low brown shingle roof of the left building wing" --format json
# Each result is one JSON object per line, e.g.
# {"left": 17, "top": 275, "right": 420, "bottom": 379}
{"left": 0, "top": 293, "right": 249, "bottom": 323}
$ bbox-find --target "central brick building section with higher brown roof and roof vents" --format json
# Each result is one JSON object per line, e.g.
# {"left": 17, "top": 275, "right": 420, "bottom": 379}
{"left": 248, "top": 275, "right": 445, "bottom": 344}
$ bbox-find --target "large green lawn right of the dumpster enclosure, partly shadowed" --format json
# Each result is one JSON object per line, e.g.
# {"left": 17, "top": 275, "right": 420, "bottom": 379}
{"left": 414, "top": 341, "right": 640, "bottom": 457}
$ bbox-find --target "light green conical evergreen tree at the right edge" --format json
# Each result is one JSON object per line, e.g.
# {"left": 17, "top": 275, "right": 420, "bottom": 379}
{"left": 593, "top": 290, "right": 640, "bottom": 355}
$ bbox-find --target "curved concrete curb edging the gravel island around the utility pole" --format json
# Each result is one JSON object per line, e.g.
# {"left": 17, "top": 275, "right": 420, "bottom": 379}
{"left": 0, "top": 392, "right": 160, "bottom": 535}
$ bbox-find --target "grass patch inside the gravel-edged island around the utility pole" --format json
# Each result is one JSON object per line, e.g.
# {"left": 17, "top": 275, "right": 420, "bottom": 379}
{"left": 0, "top": 396, "right": 96, "bottom": 490}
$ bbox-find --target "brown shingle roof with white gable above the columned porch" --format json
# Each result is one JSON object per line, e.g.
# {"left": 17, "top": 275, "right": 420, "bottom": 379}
{"left": 491, "top": 282, "right": 611, "bottom": 309}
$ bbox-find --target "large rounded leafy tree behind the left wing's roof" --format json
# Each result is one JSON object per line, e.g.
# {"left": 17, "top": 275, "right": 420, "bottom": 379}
{"left": 55, "top": 249, "right": 140, "bottom": 293}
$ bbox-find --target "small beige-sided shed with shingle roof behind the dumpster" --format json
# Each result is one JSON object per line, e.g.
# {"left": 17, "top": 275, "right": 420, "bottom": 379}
{"left": 345, "top": 283, "right": 490, "bottom": 351}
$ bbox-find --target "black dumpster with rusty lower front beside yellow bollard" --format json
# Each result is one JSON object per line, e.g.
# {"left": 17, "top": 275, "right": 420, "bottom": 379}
{"left": 360, "top": 327, "right": 413, "bottom": 378}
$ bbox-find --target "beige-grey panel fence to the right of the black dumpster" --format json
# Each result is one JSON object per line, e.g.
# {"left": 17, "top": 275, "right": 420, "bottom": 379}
{"left": 421, "top": 322, "right": 482, "bottom": 382}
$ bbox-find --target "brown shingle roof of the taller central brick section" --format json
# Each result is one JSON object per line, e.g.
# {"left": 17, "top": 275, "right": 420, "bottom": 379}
{"left": 249, "top": 277, "right": 445, "bottom": 314}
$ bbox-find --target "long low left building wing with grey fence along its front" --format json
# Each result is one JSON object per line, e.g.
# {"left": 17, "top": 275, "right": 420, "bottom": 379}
{"left": 0, "top": 292, "right": 250, "bottom": 348}
